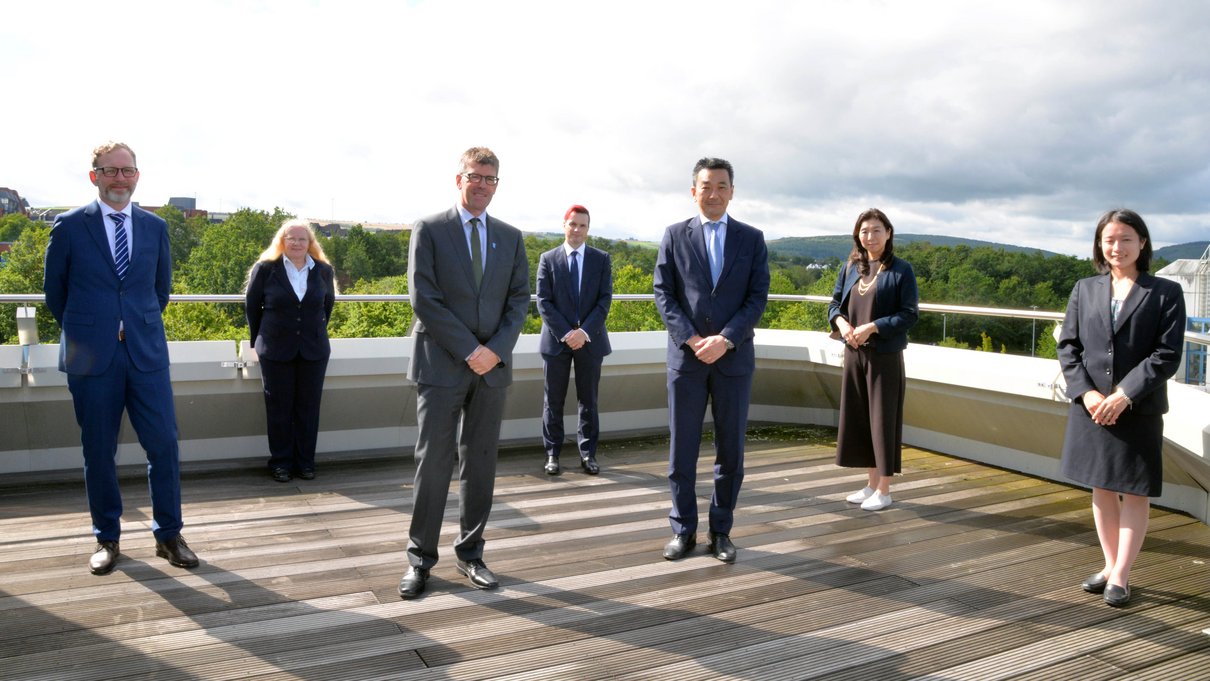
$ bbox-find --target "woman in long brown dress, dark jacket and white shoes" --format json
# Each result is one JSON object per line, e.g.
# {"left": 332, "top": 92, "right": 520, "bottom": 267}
{"left": 828, "top": 208, "right": 918, "bottom": 510}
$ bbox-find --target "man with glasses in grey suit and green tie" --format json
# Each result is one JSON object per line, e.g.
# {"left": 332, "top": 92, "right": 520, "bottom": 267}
{"left": 399, "top": 146, "right": 530, "bottom": 599}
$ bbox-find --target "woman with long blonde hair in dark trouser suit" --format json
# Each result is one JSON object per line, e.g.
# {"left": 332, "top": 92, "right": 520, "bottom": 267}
{"left": 244, "top": 220, "right": 336, "bottom": 483}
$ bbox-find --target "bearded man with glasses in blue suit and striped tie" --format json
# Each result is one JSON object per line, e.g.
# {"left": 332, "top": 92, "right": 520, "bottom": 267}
{"left": 42, "top": 142, "right": 197, "bottom": 575}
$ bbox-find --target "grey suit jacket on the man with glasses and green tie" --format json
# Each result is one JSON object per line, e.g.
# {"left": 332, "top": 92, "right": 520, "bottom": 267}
{"left": 408, "top": 208, "right": 530, "bottom": 387}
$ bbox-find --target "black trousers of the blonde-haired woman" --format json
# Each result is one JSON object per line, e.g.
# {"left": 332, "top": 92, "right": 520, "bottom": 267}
{"left": 260, "top": 354, "right": 328, "bottom": 471}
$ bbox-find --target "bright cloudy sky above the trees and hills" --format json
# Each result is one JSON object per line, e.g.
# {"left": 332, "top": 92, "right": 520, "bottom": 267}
{"left": 0, "top": 0, "right": 1210, "bottom": 256}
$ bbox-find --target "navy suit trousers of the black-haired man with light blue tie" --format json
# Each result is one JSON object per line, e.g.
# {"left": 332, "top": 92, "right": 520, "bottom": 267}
{"left": 668, "top": 365, "right": 753, "bottom": 535}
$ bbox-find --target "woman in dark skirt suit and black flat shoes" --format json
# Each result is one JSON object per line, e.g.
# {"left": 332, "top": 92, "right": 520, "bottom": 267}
{"left": 1059, "top": 209, "right": 1185, "bottom": 606}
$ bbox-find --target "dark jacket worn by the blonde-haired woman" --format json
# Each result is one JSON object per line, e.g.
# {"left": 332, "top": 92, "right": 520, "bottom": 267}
{"left": 244, "top": 255, "right": 336, "bottom": 362}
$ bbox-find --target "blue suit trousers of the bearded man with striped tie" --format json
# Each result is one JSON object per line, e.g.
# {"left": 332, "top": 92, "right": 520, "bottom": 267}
{"left": 68, "top": 342, "right": 183, "bottom": 542}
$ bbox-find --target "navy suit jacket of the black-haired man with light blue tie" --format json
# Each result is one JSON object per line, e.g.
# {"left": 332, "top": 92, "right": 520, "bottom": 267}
{"left": 655, "top": 217, "right": 768, "bottom": 376}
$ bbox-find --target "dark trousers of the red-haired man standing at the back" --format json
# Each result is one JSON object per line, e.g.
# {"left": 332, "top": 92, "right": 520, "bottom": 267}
{"left": 542, "top": 347, "right": 601, "bottom": 458}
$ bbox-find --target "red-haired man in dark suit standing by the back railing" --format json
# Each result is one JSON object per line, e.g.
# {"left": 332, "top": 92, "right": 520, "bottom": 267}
{"left": 537, "top": 206, "right": 613, "bottom": 475}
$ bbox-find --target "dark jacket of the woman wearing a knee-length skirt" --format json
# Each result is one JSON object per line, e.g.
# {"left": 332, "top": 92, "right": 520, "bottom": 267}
{"left": 1059, "top": 272, "right": 1185, "bottom": 414}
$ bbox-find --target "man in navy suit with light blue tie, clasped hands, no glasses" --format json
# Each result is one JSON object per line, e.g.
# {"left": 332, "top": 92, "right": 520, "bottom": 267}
{"left": 655, "top": 158, "right": 768, "bottom": 562}
